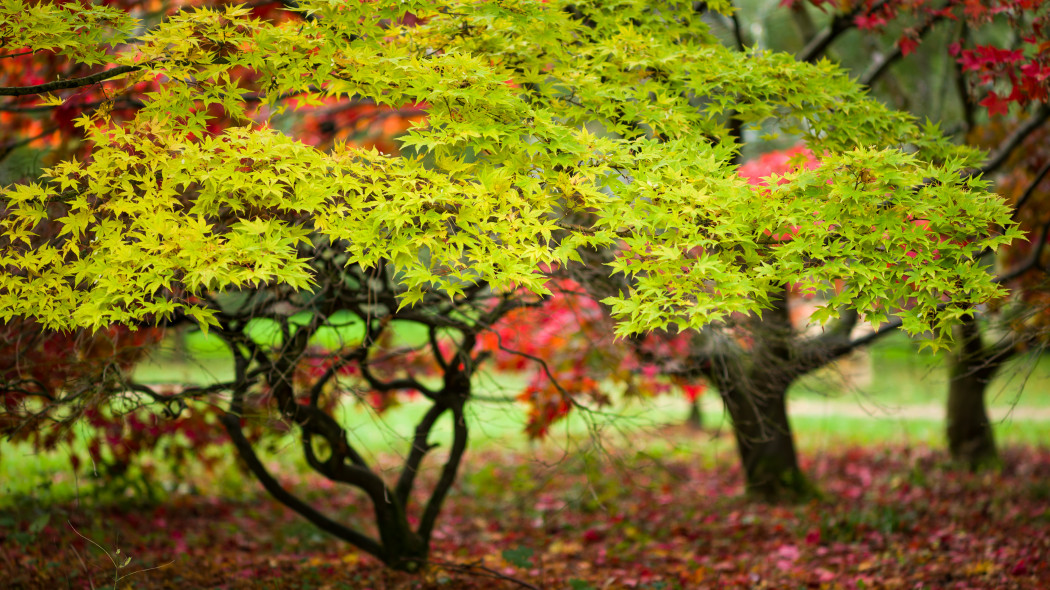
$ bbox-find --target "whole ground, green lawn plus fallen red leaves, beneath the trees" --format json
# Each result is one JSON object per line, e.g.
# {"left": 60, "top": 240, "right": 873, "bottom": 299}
{"left": 0, "top": 327, "right": 1050, "bottom": 590}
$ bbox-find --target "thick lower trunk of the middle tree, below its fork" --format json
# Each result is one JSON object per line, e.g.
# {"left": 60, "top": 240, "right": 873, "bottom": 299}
{"left": 721, "top": 379, "right": 817, "bottom": 503}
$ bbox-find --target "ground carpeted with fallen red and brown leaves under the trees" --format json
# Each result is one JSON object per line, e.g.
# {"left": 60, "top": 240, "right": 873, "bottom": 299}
{"left": 0, "top": 436, "right": 1050, "bottom": 590}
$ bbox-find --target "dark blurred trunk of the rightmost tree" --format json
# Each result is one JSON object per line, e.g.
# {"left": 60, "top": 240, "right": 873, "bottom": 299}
{"left": 947, "top": 319, "right": 1006, "bottom": 470}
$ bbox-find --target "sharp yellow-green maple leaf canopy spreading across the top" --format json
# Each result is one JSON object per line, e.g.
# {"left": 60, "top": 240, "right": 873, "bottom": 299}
{"left": 0, "top": 0, "right": 1019, "bottom": 334}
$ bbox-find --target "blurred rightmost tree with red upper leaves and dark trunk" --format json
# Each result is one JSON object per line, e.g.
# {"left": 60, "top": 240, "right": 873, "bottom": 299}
{"left": 747, "top": 0, "right": 1050, "bottom": 468}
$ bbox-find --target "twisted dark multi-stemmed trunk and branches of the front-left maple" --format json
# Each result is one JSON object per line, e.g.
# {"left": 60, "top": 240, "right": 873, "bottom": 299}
{"left": 206, "top": 255, "right": 533, "bottom": 571}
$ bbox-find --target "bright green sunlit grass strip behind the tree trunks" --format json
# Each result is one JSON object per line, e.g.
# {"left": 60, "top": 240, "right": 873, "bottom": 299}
{"left": 0, "top": 326, "right": 1050, "bottom": 505}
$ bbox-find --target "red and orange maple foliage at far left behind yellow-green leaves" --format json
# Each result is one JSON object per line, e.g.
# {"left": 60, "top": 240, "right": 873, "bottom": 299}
{"left": 0, "top": 0, "right": 438, "bottom": 497}
